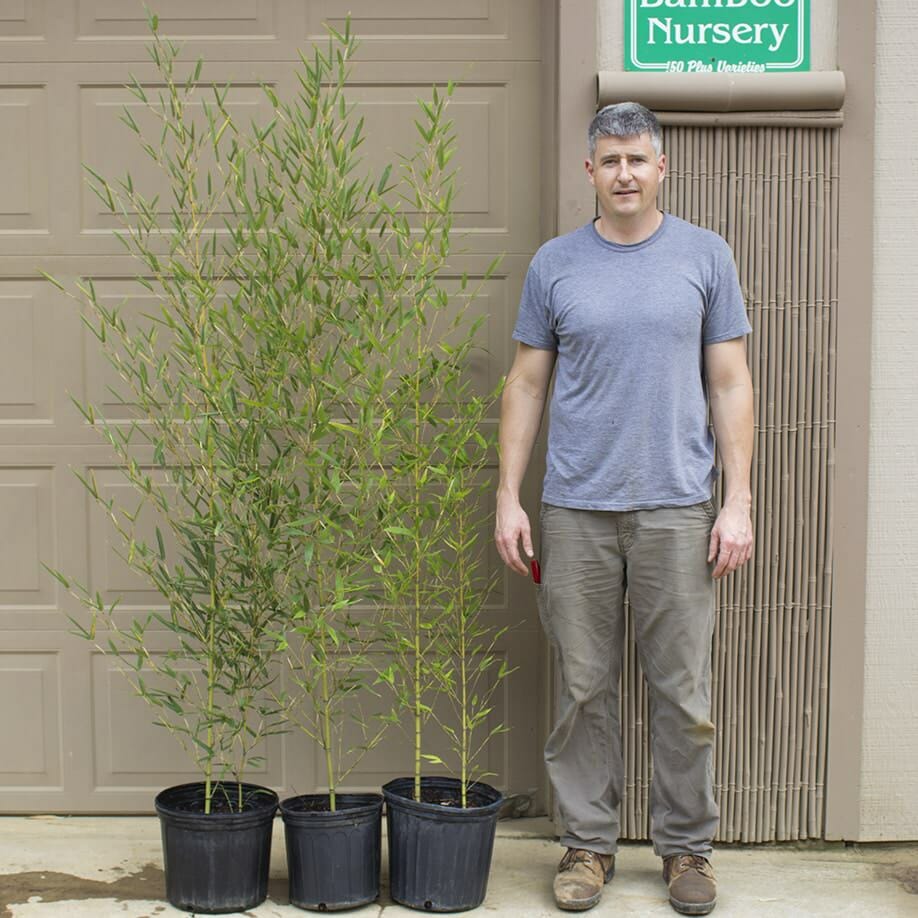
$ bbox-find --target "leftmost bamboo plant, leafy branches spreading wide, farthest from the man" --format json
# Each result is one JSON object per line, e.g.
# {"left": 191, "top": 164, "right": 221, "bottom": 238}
{"left": 46, "top": 10, "right": 310, "bottom": 813}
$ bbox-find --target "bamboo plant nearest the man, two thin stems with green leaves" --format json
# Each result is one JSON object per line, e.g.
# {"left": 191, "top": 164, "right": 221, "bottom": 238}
{"left": 375, "top": 85, "right": 507, "bottom": 806}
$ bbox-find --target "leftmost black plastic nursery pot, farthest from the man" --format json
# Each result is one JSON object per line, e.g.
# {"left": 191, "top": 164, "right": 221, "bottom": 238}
{"left": 155, "top": 781, "right": 277, "bottom": 915}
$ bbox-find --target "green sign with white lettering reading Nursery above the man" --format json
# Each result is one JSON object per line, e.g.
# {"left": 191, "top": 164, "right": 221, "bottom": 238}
{"left": 625, "top": 0, "right": 810, "bottom": 73}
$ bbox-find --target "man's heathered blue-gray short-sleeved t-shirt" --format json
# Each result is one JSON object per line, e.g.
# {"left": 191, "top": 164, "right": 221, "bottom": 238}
{"left": 513, "top": 214, "right": 751, "bottom": 510}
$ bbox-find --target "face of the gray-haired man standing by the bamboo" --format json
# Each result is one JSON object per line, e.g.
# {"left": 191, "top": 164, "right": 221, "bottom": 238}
{"left": 586, "top": 134, "right": 666, "bottom": 223}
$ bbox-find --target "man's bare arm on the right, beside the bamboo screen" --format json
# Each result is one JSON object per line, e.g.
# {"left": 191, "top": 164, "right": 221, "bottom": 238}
{"left": 704, "top": 338, "right": 753, "bottom": 579}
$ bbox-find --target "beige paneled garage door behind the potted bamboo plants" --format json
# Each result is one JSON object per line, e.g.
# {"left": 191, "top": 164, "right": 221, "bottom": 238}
{"left": 0, "top": 0, "right": 542, "bottom": 812}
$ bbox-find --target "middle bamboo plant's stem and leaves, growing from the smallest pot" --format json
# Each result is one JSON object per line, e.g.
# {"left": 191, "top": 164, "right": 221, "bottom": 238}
{"left": 226, "top": 23, "right": 411, "bottom": 810}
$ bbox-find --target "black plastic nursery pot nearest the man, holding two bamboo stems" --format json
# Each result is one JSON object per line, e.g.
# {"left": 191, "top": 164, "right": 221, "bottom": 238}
{"left": 383, "top": 778, "right": 503, "bottom": 912}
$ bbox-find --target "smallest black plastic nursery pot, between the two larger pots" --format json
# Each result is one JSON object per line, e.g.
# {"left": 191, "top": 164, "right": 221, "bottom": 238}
{"left": 280, "top": 794, "right": 382, "bottom": 912}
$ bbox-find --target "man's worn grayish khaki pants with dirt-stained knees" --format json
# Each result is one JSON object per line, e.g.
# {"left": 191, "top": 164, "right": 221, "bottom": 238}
{"left": 536, "top": 501, "right": 718, "bottom": 857}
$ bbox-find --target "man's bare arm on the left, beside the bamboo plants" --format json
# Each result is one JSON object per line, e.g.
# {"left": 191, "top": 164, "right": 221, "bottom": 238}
{"left": 494, "top": 343, "right": 557, "bottom": 575}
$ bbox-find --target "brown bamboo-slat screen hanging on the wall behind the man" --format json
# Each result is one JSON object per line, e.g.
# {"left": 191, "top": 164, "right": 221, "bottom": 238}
{"left": 621, "top": 125, "right": 839, "bottom": 842}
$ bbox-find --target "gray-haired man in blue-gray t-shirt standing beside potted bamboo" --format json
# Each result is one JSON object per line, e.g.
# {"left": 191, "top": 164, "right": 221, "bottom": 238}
{"left": 495, "top": 103, "right": 753, "bottom": 915}
